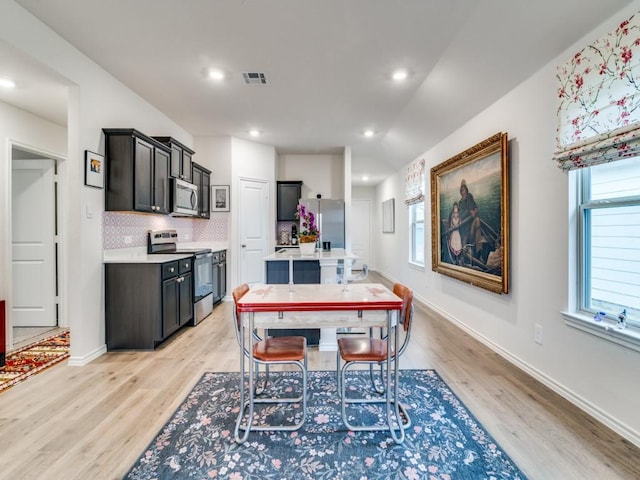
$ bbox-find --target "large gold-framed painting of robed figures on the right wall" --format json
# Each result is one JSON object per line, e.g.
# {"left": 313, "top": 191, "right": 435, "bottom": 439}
{"left": 431, "top": 133, "right": 509, "bottom": 293}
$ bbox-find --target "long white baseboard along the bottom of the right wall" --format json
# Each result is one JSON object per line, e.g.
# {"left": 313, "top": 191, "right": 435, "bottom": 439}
{"left": 377, "top": 272, "right": 640, "bottom": 447}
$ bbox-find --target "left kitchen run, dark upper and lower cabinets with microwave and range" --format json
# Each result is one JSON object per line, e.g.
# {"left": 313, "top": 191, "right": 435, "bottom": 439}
{"left": 103, "top": 128, "right": 227, "bottom": 350}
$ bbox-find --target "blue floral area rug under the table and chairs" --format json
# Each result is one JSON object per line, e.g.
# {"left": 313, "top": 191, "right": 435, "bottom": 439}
{"left": 125, "top": 370, "right": 525, "bottom": 480}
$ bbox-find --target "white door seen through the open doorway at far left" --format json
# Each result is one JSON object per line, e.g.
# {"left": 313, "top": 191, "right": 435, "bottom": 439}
{"left": 11, "top": 159, "right": 57, "bottom": 327}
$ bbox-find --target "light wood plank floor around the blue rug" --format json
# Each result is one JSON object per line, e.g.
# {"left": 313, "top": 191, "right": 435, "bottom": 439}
{"left": 0, "top": 273, "right": 640, "bottom": 480}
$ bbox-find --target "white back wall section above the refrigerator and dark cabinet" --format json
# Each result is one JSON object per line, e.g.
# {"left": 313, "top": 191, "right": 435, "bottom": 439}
{"left": 277, "top": 154, "right": 345, "bottom": 199}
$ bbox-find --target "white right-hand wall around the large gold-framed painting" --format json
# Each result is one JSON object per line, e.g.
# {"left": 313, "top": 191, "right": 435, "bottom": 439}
{"left": 377, "top": 1, "right": 640, "bottom": 445}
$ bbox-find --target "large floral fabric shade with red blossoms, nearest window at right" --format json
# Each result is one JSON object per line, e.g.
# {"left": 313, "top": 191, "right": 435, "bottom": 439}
{"left": 554, "top": 14, "right": 640, "bottom": 171}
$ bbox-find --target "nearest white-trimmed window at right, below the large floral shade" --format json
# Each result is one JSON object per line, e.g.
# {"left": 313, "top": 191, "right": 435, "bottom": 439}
{"left": 577, "top": 157, "right": 640, "bottom": 327}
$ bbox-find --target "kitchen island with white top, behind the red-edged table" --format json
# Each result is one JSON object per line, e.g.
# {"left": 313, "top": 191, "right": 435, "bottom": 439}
{"left": 264, "top": 248, "right": 358, "bottom": 351}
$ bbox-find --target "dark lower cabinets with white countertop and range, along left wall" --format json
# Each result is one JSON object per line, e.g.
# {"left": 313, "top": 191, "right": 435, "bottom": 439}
{"left": 104, "top": 227, "right": 227, "bottom": 350}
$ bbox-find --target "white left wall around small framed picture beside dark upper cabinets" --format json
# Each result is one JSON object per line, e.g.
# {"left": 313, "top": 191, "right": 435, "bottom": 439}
{"left": 0, "top": 0, "right": 192, "bottom": 365}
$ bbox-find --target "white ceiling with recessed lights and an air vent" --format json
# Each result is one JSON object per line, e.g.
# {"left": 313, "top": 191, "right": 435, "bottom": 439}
{"left": 0, "top": 0, "right": 631, "bottom": 185}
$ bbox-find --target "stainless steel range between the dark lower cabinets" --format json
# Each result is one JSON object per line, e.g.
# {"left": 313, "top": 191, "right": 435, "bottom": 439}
{"left": 147, "top": 230, "right": 213, "bottom": 325}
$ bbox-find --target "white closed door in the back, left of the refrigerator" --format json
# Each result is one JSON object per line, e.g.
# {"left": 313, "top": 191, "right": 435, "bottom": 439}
{"left": 238, "top": 179, "right": 269, "bottom": 285}
